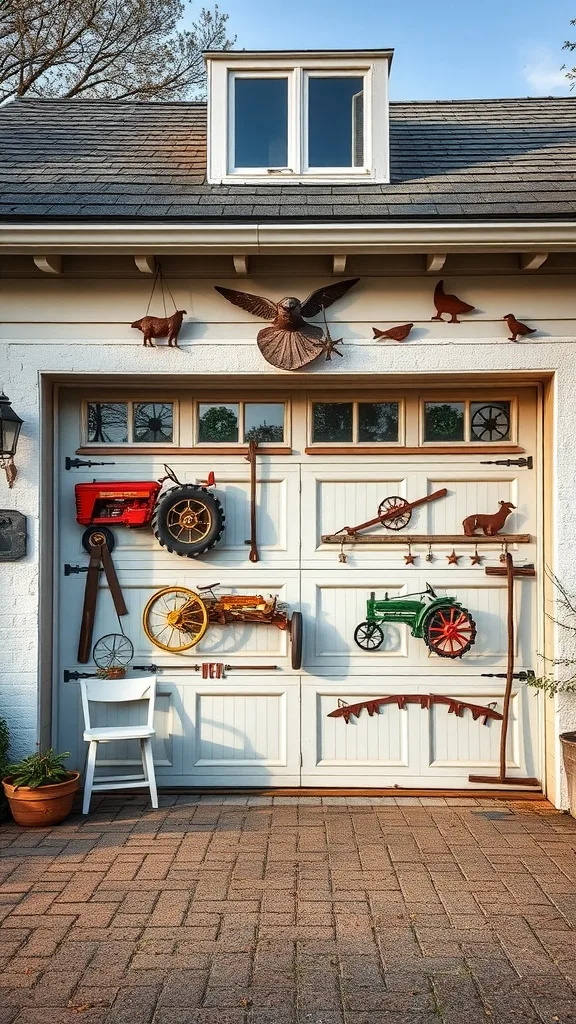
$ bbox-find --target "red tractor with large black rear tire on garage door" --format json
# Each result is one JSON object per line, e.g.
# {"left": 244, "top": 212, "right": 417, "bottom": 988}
{"left": 75, "top": 466, "right": 225, "bottom": 558}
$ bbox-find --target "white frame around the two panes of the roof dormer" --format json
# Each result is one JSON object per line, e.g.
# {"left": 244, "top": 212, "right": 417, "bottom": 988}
{"left": 206, "top": 51, "right": 390, "bottom": 184}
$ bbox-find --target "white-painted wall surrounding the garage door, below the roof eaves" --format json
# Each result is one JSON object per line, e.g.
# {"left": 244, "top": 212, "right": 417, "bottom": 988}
{"left": 0, "top": 273, "right": 576, "bottom": 801}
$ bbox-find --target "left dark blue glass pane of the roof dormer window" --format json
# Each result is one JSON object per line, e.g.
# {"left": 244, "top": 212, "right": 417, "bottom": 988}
{"left": 234, "top": 78, "right": 288, "bottom": 167}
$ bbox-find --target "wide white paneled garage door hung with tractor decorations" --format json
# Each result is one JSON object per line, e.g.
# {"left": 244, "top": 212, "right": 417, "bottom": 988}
{"left": 55, "top": 388, "right": 540, "bottom": 788}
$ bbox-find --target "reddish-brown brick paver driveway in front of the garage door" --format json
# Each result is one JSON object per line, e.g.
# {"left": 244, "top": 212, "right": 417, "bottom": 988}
{"left": 0, "top": 796, "right": 576, "bottom": 1024}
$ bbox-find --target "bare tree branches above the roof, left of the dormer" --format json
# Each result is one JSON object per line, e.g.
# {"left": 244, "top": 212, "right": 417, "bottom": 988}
{"left": 0, "top": 0, "right": 234, "bottom": 99}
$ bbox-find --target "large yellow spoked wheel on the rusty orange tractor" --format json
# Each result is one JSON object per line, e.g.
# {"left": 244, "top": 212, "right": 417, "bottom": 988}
{"left": 143, "top": 587, "right": 208, "bottom": 653}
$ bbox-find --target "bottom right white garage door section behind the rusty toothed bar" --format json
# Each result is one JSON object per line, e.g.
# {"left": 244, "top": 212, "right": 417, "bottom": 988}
{"left": 302, "top": 676, "right": 539, "bottom": 787}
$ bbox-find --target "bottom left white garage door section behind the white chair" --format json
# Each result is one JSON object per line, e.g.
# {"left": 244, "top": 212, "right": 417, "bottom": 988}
{"left": 59, "top": 672, "right": 299, "bottom": 785}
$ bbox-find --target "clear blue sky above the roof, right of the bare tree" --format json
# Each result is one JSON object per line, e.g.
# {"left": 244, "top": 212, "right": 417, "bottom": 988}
{"left": 216, "top": 0, "right": 576, "bottom": 99}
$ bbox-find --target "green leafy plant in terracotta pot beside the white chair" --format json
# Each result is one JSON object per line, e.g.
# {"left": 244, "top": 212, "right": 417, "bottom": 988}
{"left": 2, "top": 750, "right": 80, "bottom": 827}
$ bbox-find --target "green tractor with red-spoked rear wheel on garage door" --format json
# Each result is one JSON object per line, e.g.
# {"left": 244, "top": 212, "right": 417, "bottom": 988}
{"left": 354, "top": 583, "right": 476, "bottom": 657}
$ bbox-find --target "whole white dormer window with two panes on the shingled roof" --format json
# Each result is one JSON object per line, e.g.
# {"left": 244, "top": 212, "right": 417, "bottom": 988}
{"left": 206, "top": 50, "right": 392, "bottom": 183}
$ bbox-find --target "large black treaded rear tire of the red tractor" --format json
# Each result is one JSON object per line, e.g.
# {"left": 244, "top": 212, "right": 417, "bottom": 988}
{"left": 152, "top": 483, "right": 225, "bottom": 558}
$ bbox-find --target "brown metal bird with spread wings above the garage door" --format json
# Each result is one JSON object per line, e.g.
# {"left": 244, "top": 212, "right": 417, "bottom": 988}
{"left": 214, "top": 278, "right": 360, "bottom": 370}
